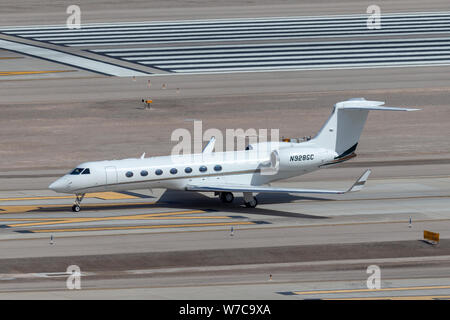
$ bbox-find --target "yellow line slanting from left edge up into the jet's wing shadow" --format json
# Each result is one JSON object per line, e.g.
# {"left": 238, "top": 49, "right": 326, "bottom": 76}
{"left": 8, "top": 210, "right": 209, "bottom": 228}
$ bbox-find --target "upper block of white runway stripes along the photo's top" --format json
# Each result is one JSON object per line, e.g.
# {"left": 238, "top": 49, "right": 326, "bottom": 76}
{"left": 2, "top": 12, "right": 450, "bottom": 46}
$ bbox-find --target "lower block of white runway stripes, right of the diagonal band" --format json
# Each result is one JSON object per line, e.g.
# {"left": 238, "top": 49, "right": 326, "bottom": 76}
{"left": 92, "top": 38, "right": 450, "bottom": 73}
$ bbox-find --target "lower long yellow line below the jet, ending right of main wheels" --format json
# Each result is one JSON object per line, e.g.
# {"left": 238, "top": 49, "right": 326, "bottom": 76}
{"left": 29, "top": 221, "right": 255, "bottom": 233}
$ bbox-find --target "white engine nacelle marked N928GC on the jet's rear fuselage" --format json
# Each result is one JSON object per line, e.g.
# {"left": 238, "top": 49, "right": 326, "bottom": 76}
{"left": 270, "top": 147, "right": 335, "bottom": 171}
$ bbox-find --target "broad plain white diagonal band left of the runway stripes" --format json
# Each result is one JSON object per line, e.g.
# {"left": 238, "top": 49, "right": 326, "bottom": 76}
{"left": 0, "top": 39, "right": 148, "bottom": 77}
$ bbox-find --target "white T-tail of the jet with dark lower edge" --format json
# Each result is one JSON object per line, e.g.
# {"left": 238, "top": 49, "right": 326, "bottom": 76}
{"left": 310, "top": 98, "right": 420, "bottom": 165}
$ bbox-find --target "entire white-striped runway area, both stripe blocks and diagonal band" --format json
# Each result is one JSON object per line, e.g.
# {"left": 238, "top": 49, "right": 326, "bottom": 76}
{"left": 0, "top": 12, "right": 450, "bottom": 77}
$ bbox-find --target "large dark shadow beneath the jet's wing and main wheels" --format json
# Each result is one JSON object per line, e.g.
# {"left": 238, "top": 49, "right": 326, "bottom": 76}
{"left": 156, "top": 190, "right": 330, "bottom": 219}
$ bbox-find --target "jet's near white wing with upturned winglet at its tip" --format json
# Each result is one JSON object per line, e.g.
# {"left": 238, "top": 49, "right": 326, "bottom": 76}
{"left": 186, "top": 169, "right": 371, "bottom": 194}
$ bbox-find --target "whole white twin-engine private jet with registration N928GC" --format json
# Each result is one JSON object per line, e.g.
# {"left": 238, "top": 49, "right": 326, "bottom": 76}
{"left": 49, "top": 98, "right": 418, "bottom": 212}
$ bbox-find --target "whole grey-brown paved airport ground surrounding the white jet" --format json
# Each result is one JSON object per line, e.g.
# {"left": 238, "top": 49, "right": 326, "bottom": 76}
{"left": 0, "top": 0, "right": 450, "bottom": 299}
